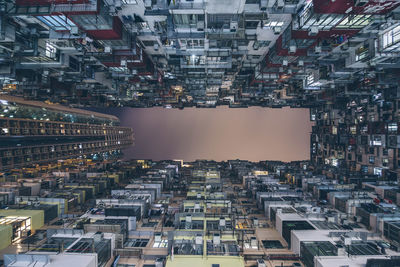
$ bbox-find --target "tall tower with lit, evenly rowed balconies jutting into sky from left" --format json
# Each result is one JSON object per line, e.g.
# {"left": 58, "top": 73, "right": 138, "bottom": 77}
{"left": 0, "top": 96, "right": 133, "bottom": 169}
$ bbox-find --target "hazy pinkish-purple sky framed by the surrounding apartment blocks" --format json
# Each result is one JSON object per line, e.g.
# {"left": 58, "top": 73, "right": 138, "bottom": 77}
{"left": 92, "top": 106, "right": 312, "bottom": 161}
